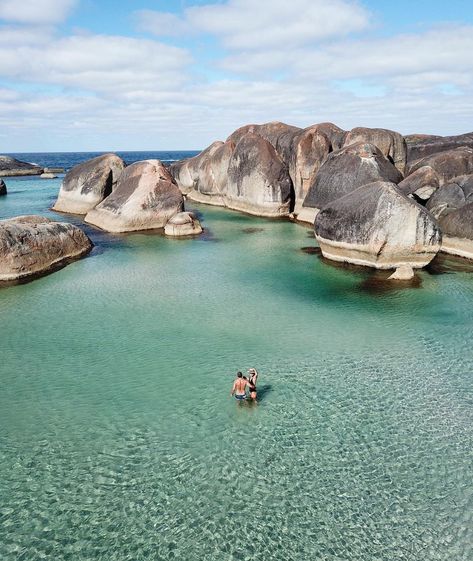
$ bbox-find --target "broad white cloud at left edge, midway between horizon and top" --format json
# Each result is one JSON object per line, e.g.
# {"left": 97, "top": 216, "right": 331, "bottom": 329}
{"left": 0, "top": 35, "right": 191, "bottom": 95}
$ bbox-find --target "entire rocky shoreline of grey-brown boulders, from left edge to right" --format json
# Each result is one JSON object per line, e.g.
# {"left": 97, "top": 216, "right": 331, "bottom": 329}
{"left": 0, "top": 122, "right": 473, "bottom": 280}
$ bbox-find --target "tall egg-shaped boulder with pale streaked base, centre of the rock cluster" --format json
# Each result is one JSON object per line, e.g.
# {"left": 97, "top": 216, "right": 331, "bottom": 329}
{"left": 225, "top": 132, "right": 294, "bottom": 217}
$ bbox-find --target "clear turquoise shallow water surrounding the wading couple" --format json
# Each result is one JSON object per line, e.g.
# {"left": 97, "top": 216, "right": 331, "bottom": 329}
{"left": 0, "top": 179, "right": 473, "bottom": 561}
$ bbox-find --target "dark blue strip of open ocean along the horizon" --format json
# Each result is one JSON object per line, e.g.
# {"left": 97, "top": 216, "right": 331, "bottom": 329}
{"left": 4, "top": 150, "right": 199, "bottom": 171}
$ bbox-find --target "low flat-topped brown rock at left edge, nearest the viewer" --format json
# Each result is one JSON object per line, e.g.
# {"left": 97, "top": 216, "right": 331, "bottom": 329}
{"left": 0, "top": 216, "right": 92, "bottom": 281}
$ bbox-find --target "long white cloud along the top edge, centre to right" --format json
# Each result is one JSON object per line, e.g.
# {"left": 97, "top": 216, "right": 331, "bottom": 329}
{"left": 137, "top": 0, "right": 370, "bottom": 50}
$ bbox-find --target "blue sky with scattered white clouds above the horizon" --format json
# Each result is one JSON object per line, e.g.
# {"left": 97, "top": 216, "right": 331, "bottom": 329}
{"left": 0, "top": 0, "right": 473, "bottom": 153}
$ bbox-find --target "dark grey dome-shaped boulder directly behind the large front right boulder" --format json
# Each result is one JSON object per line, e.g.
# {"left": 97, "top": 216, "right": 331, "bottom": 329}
{"left": 298, "top": 142, "right": 402, "bottom": 219}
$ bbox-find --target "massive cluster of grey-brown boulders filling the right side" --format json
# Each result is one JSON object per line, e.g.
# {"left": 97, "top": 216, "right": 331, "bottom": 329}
{"left": 170, "top": 122, "right": 473, "bottom": 278}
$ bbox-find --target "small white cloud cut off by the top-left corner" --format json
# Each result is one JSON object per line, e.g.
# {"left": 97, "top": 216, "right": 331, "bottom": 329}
{"left": 0, "top": 0, "right": 77, "bottom": 25}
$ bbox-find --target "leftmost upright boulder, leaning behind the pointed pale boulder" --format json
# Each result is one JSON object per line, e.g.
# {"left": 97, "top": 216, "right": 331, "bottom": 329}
{"left": 53, "top": 154, "right": 125, "bottom": 214}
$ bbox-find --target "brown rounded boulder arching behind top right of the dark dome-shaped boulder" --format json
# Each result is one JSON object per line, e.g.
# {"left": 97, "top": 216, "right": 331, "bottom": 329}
{"left": 343, "top": 127, "right": 407, "bottom": 174}
